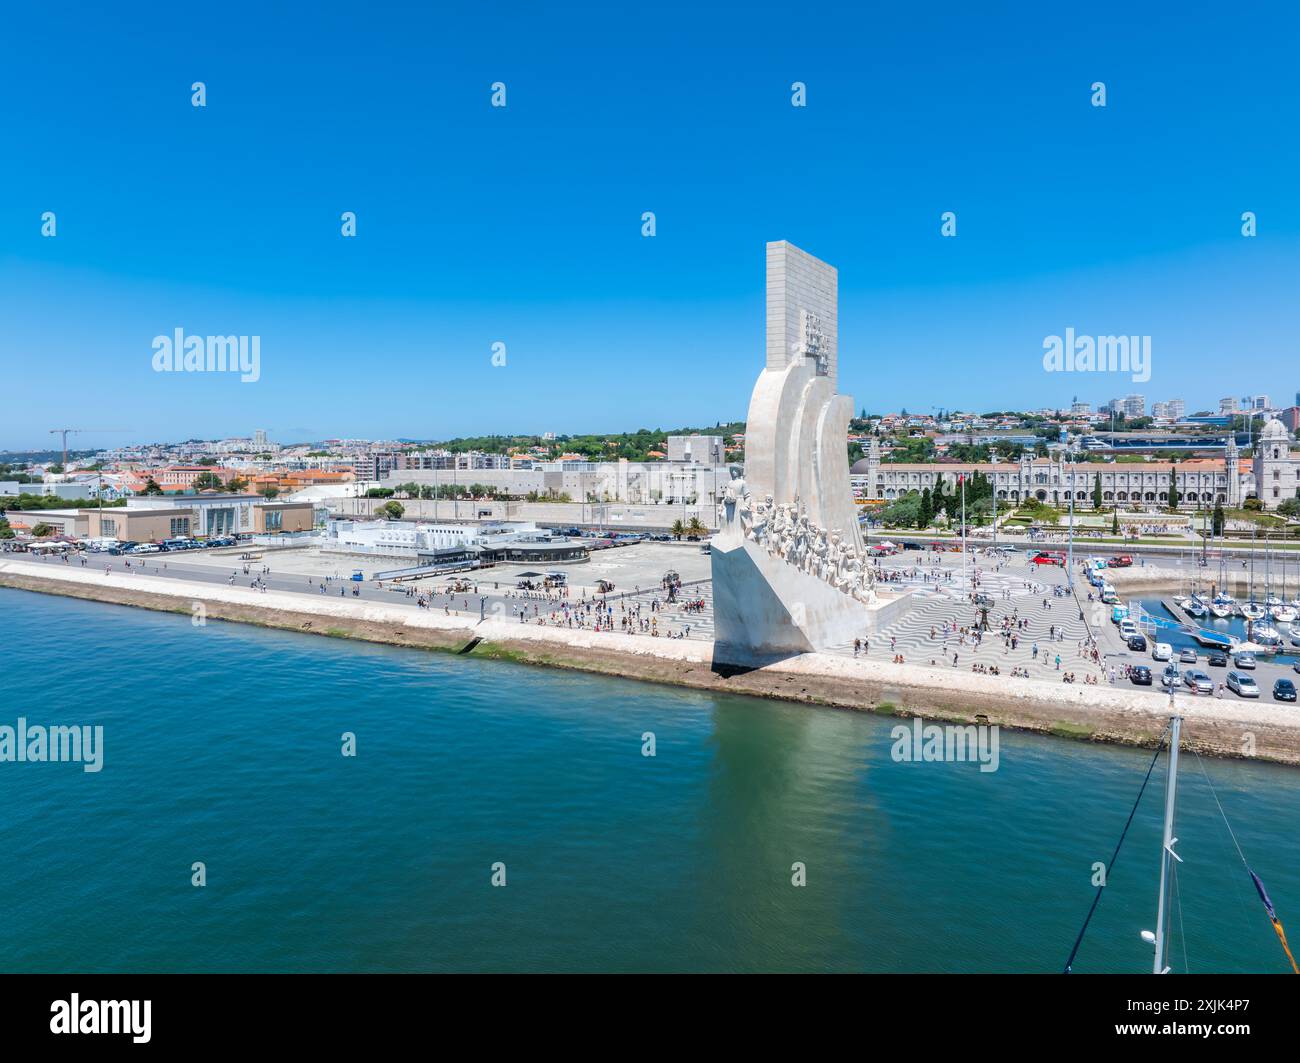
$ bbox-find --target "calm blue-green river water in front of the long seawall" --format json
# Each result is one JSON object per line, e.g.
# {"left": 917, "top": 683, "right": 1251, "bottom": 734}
{"left": 0, "top": 590, "right": 1300, "bottom": 972}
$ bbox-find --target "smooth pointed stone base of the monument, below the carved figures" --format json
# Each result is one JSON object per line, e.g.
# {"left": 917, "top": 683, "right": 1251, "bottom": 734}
{"left": 710, "top": 535, "right": 898, "bottom": 664}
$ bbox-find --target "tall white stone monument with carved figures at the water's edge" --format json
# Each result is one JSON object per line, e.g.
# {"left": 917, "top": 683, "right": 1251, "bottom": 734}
{"left": 711, "top": 240, "right": 904, "bottom": 663}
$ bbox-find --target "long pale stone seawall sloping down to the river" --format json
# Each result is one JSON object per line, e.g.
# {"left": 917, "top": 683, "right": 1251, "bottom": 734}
{"left": 0, "top": 560, "right": 1300, "bottom": 764}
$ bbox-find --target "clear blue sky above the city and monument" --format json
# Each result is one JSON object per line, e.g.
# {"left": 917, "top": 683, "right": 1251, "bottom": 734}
{"left": 0, "top": 3, "right": 1300, "bottom": 448}
